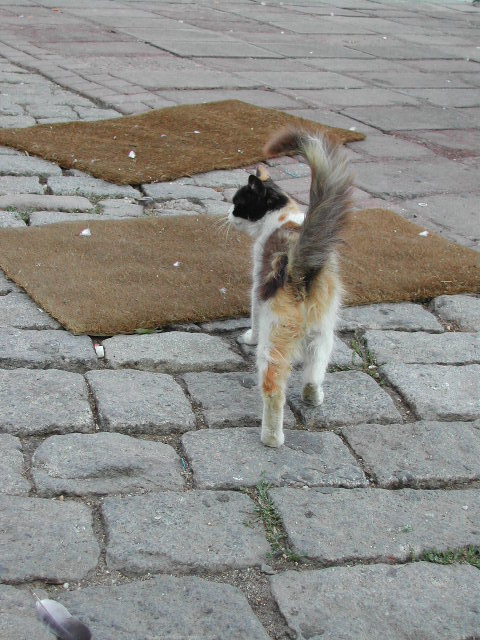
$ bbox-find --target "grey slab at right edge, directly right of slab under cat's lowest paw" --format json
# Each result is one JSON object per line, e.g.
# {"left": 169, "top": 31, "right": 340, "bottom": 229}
{"left": 342, "top": 421, "right": 480, "bottom": 489}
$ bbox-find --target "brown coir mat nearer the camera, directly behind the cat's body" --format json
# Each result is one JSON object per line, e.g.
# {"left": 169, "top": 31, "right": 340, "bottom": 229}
{"left": 0, "top": 209, "right": 480, "bottom": 335}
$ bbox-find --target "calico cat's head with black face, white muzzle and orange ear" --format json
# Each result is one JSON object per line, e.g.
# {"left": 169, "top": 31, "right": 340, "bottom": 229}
{"left": 228, "top": 166, "right": 289, "bottom": 235}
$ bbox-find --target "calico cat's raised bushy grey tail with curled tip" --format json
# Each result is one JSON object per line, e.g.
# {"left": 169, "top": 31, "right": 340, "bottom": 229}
{"left": 265, "top": 129, "right": 352, "bottom": 287}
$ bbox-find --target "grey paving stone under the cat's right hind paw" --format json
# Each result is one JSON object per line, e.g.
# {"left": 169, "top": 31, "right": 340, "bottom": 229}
{"left": 288, "top": 371, "right": 401, "bottom": 429}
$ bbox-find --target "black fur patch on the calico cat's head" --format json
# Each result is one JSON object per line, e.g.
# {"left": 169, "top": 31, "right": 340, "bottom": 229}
{"left": 233, "top": 175, "right": 288, "bottom": 222}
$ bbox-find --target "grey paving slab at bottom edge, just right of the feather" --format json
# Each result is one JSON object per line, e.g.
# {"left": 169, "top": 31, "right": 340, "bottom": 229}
{"left": 59, "top": 576, "right": 269, "bottom": 640}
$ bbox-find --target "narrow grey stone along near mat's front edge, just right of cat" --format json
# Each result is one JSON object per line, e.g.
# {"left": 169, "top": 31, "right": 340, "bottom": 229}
{"left": 338, "top": 302, "right": 443, "bottom": 333}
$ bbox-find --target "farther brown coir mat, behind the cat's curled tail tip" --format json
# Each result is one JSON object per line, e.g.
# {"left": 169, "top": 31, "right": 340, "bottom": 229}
{"left": 0, "top": 100, "right": 365, "bottom": 185}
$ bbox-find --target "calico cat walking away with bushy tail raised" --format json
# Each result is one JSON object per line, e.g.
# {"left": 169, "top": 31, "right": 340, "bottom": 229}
{"left": 229, "top": 130, "right": 352, "bottom": 447}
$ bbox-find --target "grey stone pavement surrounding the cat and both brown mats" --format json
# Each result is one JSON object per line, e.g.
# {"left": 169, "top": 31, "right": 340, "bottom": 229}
{"left": 0, "top": 0, "right": 480, "bottom": 640}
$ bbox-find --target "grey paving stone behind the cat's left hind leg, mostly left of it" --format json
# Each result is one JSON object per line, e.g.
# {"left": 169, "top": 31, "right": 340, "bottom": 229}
{"left": 183, "top": 371, "right": 295, "bottom": 428}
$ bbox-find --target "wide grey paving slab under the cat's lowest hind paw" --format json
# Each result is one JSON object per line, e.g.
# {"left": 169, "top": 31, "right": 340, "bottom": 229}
{"left": 182, "top": 429, "right": 367, "bottom": 489}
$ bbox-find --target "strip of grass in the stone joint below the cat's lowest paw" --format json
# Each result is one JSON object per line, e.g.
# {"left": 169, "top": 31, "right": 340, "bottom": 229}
{"left": 254, "top": 474, "right": 302, "bottom": 562}
